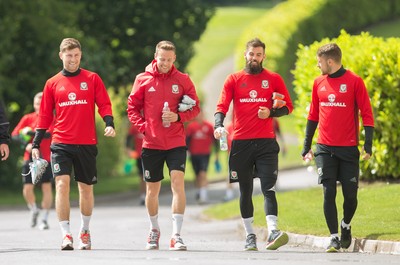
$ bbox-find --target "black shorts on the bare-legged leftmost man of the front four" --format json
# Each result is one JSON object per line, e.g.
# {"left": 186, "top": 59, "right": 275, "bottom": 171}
{"left": 50, "top": 144, "right": 97, "bottom": 185}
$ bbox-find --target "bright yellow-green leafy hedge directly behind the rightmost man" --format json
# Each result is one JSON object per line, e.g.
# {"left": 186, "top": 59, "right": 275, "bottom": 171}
{"left": 293, "top": 31, "right": 400, "bottom": 180}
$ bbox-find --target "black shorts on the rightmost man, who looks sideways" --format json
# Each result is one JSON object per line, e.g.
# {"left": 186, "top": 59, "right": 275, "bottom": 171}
{"left": 314, "top": 144, "right": 360, "bottom": 184}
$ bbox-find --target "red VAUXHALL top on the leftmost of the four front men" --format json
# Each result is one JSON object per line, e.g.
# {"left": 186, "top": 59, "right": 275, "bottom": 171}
{"left": 37, "top": 69, "right": 112, "bottom": 145}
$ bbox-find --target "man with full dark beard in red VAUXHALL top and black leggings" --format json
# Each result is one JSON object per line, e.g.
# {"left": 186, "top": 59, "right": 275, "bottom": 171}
{"left": 214, "top": 38, "right": 293, "bottom": 250}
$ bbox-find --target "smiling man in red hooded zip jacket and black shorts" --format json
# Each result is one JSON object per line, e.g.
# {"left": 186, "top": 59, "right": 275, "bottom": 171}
{"left": 127, "top": 41, "right": 200, "bottom": 250}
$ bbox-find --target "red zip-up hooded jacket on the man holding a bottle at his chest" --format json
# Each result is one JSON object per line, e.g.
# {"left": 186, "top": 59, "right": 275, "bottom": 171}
{"left": 127, "top": 60, "right": 200, "bottom": 150}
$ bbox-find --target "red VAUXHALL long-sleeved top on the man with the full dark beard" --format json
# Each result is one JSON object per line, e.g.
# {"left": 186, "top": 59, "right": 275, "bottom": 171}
{"left": 216, "top": 69, "right": 293, "bottom": 140}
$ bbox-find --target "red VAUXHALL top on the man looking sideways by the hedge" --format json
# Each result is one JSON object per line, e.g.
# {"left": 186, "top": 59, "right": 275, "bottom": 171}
{"left": 308, "top": 70, "right": 374, "bottom": 146}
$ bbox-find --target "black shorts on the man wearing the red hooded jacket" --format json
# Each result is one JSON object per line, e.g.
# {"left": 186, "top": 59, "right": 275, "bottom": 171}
{"left": 142, "top": 146, "right": 187, "bottom": 182}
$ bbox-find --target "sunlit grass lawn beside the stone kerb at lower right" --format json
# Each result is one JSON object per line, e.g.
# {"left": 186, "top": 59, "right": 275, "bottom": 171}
{"left": 204, "top": 183, "right": 400, "bottom": 241}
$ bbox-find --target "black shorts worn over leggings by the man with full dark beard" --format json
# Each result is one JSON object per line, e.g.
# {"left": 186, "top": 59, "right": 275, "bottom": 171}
{"left": 229, "top": 138, "right": 280, "bottom": 183}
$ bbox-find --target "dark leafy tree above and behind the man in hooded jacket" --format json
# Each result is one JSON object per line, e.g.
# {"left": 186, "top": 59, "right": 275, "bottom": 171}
{"left": 73, "top": 0, "right": 214, "bottom": 88}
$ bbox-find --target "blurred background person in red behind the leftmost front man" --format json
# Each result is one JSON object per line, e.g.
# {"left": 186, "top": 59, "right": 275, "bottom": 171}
{"left": 11, "top": 92, "right": 53, "bottom": 230}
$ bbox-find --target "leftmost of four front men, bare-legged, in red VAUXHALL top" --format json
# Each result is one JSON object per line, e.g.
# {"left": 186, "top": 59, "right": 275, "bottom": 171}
{"left": 32, "top": 38, "right": 115, "bottom": 250}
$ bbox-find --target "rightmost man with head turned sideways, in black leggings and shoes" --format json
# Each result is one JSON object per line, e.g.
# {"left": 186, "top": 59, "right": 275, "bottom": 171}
{"left": 301, "top": 43, "right": 374, "bottom": 252}
